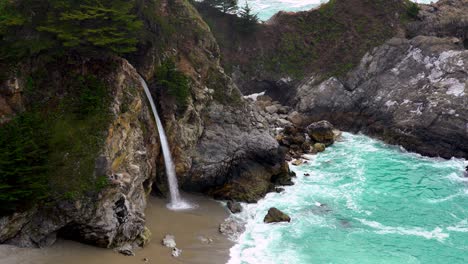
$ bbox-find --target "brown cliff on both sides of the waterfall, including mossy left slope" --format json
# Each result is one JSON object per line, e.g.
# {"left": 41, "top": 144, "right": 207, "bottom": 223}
{"left": 0, "top": 0, "right": 290, "bottom": 251}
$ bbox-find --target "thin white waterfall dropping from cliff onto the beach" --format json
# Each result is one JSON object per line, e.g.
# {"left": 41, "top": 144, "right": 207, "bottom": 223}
{"left": 140, "top": 76, "right": 193, "bottom": 210}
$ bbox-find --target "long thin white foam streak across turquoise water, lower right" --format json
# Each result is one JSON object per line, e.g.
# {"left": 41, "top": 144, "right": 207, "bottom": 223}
{"left": 356, "top": 218, "right": 450, "bottom": 242}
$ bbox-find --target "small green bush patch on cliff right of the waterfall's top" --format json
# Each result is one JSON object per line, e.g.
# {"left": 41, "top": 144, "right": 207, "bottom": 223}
{"left": 155, "top": 60, "right": 190, "bottom": 110}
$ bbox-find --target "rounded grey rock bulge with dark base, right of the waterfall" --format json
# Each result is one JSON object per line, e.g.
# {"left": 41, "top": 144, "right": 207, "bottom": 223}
{"left": 184, "top": 103, "right": 289, "bottom": 202}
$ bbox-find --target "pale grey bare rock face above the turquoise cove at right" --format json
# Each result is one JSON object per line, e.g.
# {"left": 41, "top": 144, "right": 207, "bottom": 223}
{"left": 297, "top": 36, "right": 468, "bottom": 158}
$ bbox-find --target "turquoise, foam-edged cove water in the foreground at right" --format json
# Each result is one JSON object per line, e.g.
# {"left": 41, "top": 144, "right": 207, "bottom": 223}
{"left": 229, "top": 133, "right": 468, "bottom": 264}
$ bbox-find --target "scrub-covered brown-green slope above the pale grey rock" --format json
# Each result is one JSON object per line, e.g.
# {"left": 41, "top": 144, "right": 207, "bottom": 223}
{"left": 194, "top": 0, "right": 408, "bottom": 104}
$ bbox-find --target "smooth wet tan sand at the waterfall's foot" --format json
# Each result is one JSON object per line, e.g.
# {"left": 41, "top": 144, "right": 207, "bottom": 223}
{"left": 0, "top": 194, "right": 233, "bottom": 264}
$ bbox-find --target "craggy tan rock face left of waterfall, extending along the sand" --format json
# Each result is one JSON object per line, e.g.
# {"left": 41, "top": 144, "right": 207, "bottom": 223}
{"left": 0, "top": 59, "right": 159, "bottom": 250}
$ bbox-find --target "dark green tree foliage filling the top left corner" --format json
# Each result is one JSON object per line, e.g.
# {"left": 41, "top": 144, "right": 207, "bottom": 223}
{"left": 0, "top": 0, "right": 143, "bottom": 65}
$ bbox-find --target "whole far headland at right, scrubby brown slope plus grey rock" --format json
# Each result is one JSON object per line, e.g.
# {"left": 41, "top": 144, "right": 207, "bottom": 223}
{"left": 200, "top": 0, "right": 468, "bottom": 158}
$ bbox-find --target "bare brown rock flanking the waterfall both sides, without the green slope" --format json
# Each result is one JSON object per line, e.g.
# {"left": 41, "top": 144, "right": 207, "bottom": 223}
{"left": 0, "top": 0, "right": 290, "bottom": 250}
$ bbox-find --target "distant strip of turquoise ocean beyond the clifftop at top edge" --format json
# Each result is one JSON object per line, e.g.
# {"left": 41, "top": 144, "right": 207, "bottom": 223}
{"left": 247, "top": 0, "right": 436, "bottom": 21}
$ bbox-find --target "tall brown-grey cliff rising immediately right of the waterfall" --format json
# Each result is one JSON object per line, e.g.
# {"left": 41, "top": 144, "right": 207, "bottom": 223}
{"left": 128, "top": 0, "right": 287, "bottom": 201}
